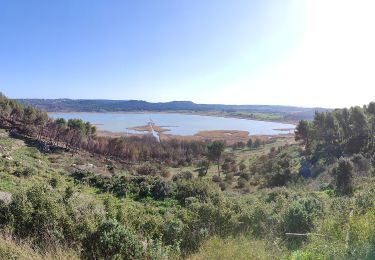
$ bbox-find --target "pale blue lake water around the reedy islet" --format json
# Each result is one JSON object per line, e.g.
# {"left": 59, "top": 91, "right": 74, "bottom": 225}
{"left": 50, "top": 113, "right": 295, "bottom": 135}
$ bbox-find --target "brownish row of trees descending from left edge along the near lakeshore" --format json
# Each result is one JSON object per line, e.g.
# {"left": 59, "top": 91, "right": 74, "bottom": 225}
{"left": 0, "top": 94, "right": 207, "bottom": 165}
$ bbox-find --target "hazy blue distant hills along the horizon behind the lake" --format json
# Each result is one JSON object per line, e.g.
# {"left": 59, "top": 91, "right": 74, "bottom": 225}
{"left": 18, "top": 99, "right": 327, "bottom": 120}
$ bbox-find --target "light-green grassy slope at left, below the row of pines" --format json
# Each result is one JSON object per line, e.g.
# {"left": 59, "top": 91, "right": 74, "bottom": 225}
{"left": 0, "top": 130, "right": 106, "bottom": 199}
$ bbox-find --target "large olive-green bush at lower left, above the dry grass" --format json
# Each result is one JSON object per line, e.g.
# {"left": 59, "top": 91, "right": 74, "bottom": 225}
{"left": 0, "top": 186, "right": 101, "bottom": 247}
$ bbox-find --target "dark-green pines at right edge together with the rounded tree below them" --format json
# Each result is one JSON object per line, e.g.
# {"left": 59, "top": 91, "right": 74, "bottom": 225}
{"left": 295, "top": 102, "right": 375, "bottom": 195}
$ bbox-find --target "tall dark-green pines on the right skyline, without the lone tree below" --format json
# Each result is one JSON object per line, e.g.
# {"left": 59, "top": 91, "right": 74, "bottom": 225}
{"left": 295, "top": 102, "right": 375, "bottom": 162}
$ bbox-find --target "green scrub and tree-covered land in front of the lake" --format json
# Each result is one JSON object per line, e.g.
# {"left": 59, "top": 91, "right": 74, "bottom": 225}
{"left": 0, "top": 93, "right": 375, "bottom": 259}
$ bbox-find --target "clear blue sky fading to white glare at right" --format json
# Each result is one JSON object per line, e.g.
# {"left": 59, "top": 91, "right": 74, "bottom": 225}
{"left": 0, "top": 0, "right": 375, "bottom": 108}
